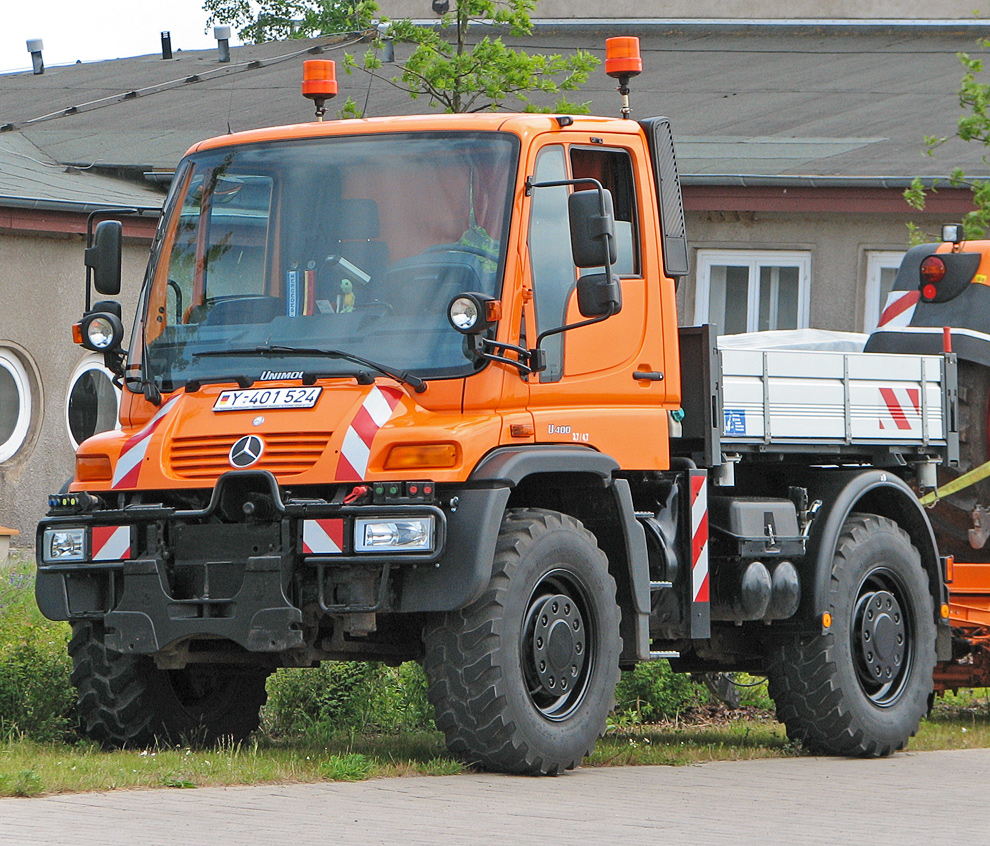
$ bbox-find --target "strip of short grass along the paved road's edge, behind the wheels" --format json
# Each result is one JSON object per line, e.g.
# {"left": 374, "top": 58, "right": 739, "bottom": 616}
{"left": 0, "top": 691, "right": 990, "bottom": 796}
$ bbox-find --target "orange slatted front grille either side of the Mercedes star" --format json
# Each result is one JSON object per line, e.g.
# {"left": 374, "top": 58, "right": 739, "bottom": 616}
{"left": 168, "top": 432, "right": 332, "bottom": 480}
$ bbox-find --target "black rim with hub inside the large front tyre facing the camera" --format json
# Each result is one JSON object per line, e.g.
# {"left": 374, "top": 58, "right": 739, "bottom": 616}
{"left": 520, "top": 570, "right": 598, "bottom": 722}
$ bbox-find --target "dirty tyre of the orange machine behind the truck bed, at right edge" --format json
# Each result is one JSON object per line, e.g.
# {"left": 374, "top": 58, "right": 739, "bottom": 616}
{"left": 929, "top": 361, "right": 990, "bottom": 562}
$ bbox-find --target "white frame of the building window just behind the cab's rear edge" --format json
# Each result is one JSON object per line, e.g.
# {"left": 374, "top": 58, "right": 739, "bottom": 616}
{"left": 694, "top": 250, "right": 811, "bottom": 332}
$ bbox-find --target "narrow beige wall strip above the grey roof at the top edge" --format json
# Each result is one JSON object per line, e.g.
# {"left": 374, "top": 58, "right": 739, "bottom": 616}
{"left": 378, "top": 0, "right": 987, "bottom": 20}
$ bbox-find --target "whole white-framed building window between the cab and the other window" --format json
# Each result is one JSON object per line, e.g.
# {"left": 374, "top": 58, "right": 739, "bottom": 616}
{"left": 694, "top": 250, "right": 811, "bottom": 335}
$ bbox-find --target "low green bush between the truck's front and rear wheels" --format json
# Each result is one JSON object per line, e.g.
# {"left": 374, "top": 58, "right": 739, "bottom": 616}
{"left": 615, "top": 661, "right": 709, "bottom": 723}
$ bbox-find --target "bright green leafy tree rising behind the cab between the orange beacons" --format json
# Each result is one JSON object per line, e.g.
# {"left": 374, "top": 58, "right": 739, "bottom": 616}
{"left": 345, "top": 0, "right": 599, "bottom": 113}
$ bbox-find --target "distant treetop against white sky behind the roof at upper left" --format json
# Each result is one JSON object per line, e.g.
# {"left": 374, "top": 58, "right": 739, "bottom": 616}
{"left": 203, "top": 0, "right": 378, "bottom": 44}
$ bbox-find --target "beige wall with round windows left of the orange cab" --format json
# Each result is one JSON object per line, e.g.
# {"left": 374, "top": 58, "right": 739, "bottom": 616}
{"left": 0, "top": 229, "right": 148, "bottom": 546}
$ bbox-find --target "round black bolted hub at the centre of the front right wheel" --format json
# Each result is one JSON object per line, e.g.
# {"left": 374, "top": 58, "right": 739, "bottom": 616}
{"left": 533, "top": 594, "right": 587, "bottom": 696}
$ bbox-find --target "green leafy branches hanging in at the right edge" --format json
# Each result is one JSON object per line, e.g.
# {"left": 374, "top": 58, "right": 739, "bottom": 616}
{"left": 904, "top": 48, "right": 990, "bottom": 242}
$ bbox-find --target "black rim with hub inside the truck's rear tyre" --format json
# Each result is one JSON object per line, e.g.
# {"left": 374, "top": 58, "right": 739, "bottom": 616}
{"left": 851, "top": 569, "right": 914, "bottom": 708}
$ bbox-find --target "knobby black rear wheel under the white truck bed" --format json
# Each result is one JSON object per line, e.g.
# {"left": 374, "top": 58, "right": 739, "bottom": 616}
{"left": 768, "top": 514, "right": 935, "bottom": 757}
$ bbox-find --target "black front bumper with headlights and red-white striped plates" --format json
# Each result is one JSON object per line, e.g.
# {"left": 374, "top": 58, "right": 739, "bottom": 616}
{"left": 36, "top": 473, "right": 458, "bottom": 654}
